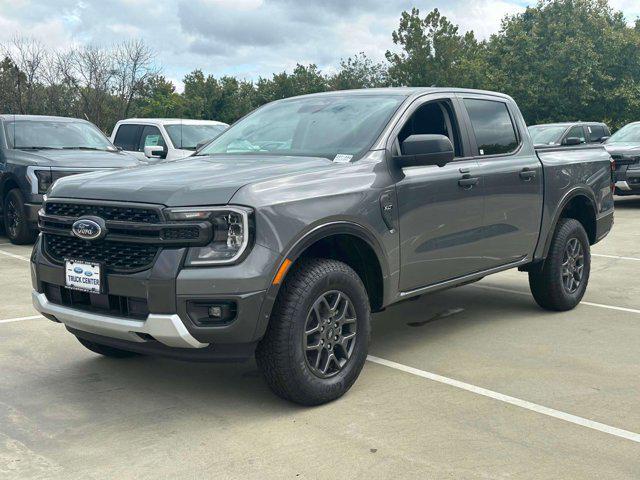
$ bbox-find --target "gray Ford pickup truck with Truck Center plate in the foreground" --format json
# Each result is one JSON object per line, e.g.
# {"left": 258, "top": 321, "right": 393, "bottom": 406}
{"left": 31, "top": 88, "right": 614, "bottom": 405}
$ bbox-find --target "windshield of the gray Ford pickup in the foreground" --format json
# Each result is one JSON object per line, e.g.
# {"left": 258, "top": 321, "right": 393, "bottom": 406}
{"left": 200, "top": 95, "right": 405, "bottom": 161}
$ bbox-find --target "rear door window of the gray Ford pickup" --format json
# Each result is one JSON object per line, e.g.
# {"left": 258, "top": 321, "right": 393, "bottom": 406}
{"left": 464, "top": 98, "right": 519, "bottom": 155}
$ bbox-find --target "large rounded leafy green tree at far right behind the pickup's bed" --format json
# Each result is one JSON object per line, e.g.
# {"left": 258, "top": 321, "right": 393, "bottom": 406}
{"left": 488, "top": 0, "right": 640, "bottom": 127}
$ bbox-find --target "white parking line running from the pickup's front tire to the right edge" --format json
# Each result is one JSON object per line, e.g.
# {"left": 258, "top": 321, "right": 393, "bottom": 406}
{"left": 367, "top": 355, "right": 640, "bottom": 443}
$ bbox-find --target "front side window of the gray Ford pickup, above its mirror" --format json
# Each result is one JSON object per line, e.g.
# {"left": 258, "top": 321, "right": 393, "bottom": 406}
{"left": 398, "top": 101, "right": 462, "bottom": 157}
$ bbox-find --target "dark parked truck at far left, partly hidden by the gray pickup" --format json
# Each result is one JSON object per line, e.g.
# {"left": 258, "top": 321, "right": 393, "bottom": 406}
{"left": 0, "top": 115, "right": 138, "bottom": 244}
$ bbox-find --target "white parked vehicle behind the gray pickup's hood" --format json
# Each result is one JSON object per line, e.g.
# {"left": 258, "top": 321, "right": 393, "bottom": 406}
{"left": 111, "top": 118, "right": 229, "bottom": 160}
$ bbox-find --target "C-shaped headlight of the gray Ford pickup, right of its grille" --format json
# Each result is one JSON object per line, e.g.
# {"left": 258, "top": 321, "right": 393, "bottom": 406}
{"left": 165, "top": 207, "right": 253, "bottom": 266}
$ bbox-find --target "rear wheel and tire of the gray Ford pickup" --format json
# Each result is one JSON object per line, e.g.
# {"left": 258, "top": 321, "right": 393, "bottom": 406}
{"left": 529, "top": 218, "right": 591, "bottom": 312}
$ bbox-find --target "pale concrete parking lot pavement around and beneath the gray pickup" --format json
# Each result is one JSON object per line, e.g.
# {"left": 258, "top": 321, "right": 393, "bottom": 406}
{"left": 0, "top": 198, "right": 640, "bottom": 479}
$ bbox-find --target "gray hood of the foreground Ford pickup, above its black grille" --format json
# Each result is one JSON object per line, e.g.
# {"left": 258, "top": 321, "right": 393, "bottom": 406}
{"left": 49, "top": 155, "right": 339, "bottom": 207}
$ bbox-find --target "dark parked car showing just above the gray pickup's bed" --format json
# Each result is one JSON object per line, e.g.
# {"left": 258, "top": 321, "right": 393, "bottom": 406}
{"left": 529, "top": 122, "right": 611, "bottom": 147}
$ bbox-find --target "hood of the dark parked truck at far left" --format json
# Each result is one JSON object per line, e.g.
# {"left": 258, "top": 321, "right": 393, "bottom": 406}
{"left": 10, "top": 150, "right": 140, "bottom": 168}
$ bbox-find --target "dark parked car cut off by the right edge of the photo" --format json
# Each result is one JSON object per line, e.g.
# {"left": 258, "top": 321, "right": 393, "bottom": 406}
{"left": 605, "top": 122, "right": 640, "bottom": 195}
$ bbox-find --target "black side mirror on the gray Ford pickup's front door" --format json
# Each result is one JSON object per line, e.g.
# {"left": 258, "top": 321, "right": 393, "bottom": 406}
{"left": 395, "top": 135, "right": 455, "bottom": 168}
